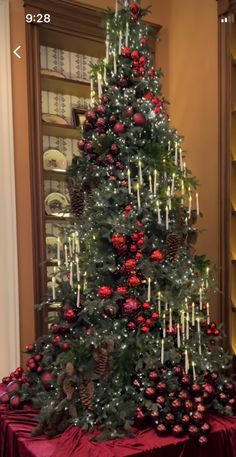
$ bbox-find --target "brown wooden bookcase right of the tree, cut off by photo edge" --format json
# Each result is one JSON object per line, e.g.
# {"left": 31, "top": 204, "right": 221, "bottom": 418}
{"left": 218, "top": 0, "right": 236, "bottom": 358}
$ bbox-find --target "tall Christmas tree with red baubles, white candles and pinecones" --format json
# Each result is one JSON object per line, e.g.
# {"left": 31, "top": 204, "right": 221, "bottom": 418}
{"left": 1, "top": 0, "right": 236, "bottom": 444}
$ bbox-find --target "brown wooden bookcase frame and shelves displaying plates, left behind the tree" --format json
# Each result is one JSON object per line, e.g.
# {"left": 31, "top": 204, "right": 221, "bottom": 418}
{"left": 23, "top": 0, "right": 160, "bottom": 336}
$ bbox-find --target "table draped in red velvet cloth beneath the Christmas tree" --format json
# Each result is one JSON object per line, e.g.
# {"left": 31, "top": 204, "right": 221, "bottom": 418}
{"left": 0, "top": 398, "right": 236, "bottom": 457}
